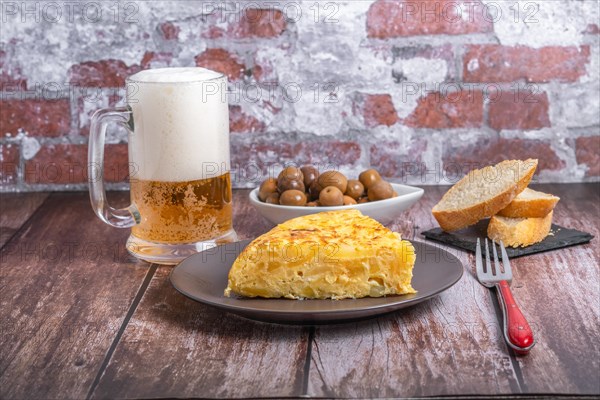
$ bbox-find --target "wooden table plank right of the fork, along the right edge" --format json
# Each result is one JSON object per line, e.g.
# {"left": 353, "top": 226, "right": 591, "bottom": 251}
{"left": 511, "top": 184, "right": 600, "bottom": 395}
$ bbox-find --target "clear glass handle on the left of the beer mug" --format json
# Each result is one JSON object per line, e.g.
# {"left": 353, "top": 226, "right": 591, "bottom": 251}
{"left": 88, "top": 107, "right": 140, "bottom": 228}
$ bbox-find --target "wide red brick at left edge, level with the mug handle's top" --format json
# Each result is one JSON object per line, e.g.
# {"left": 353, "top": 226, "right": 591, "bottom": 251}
{"left": 0, "top": 99, "right": 71, "bottom": 137}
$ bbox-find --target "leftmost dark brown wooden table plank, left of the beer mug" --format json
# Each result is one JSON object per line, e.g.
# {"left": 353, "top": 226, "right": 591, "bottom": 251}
{"left": 0, "top": 193, "right": 148, "bottom": 399}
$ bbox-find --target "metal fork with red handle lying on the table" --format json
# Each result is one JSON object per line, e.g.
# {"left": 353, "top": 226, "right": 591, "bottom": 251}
{"left": 475, "top": 238, "right": 535, "bottom": 355}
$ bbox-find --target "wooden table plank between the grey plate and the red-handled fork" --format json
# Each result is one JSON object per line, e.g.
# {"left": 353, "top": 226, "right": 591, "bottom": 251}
{"left": 308, "top": 187, "right": 520, "bottom": 398}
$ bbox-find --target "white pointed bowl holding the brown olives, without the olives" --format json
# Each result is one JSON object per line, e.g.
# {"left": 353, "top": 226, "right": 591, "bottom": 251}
{"left": 250, "top": 183, "right": 424, "bottom": 225}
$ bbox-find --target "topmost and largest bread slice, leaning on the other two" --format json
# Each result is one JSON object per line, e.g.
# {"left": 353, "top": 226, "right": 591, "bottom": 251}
{"left": 432, "top": 159, "right": 538, "bottom": 231}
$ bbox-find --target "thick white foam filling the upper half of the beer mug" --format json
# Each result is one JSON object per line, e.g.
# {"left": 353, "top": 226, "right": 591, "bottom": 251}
{"left": 127, "top": 68, "right": 229, "bottom": 182}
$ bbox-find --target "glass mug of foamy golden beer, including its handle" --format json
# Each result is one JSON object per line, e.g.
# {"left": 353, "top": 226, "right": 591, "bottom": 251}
{"left": 88, "top": 68, "right": 237, "bottom": 264}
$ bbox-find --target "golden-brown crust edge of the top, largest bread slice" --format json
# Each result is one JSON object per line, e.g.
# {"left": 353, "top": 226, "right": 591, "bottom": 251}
{"left": 432, "top": 159, "right": 538, "bottom": 231}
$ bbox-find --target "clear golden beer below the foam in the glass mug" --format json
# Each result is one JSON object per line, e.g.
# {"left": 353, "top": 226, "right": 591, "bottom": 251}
{"left": 131, "top": 172, "right": 232, "bottom": 244}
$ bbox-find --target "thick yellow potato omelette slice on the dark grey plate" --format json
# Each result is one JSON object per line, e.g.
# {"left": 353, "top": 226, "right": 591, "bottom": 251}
{"left": 225, "top": 210, "right": 415, "bottom": 299}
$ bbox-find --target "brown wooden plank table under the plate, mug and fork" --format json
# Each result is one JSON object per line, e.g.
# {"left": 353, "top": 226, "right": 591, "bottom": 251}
{"left": 0, "top": 184, "right": 600, "bottom": 399}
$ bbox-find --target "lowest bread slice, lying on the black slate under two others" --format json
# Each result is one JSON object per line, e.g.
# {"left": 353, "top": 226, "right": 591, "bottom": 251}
{"left": 488, "top": 211, "right": 552, "bottom": 247}
